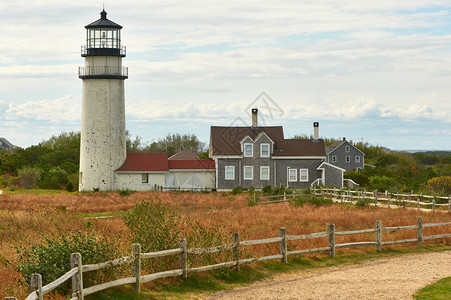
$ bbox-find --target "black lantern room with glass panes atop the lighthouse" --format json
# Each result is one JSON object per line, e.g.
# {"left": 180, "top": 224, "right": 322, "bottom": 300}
{"left": 81, "top": 10, "right": 125, "bottom": 57}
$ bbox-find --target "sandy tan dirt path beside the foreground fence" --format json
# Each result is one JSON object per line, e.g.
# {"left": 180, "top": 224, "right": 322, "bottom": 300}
{"left": 208, "top": 251, "right": 451, "bottom": 300}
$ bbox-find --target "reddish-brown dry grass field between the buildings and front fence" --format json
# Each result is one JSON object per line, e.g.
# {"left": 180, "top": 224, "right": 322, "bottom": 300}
{"left": 0, "top": 192, "right": 451, "bottom": 299}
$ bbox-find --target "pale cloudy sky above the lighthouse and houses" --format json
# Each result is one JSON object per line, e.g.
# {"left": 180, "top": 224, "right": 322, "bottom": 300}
{"left": 0, "top": 0, "right": 451, "bottom": 150}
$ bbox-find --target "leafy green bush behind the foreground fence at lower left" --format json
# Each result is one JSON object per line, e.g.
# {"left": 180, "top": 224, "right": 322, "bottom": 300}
{"left": 16, "top": 229, "right": 119, "bottom": 291}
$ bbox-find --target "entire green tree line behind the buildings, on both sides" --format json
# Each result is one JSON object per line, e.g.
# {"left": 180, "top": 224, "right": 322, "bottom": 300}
{"left": 0, "top": 132, "right": 451, "bottom": 195}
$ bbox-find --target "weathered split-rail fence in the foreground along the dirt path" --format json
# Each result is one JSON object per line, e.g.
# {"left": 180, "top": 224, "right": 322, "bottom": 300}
{"left": 5, "top": 218, "right": 451, "bottom": 300}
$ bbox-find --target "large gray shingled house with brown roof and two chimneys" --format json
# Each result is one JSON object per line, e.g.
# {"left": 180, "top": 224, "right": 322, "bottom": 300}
{"left": 209, "top": 109, "right": 345, "bottom": 190}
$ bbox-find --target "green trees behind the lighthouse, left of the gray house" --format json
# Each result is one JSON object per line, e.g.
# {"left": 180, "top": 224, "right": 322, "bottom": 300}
{"left": 0, "top": 132, "right": 208, "bottom": 191}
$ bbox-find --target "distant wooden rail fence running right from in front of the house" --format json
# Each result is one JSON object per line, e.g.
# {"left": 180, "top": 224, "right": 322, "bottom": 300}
{"left": 254, "top": 188, "right": 451, "bottom": 213}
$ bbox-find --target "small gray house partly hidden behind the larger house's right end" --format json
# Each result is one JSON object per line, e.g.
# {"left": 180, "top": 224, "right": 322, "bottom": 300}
{"left": 326, "top": 138, "right": 365, "bottom": 172}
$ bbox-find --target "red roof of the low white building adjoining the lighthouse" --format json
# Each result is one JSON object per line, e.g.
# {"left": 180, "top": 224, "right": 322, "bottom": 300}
{"left": 116, "top": 153, "right": 169, "bottom": 172}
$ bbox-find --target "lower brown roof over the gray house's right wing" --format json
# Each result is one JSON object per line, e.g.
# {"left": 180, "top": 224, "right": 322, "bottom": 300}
{"left": 273, "top": 139, "right": 326, "bottom": 156}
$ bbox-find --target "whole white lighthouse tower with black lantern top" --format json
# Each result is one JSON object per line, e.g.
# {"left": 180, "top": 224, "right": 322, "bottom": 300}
{"left": 78, "top": 10, "right": 128, "bottom": 191}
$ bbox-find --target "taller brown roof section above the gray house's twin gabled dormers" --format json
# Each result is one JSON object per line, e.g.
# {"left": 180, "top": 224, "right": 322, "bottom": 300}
{"left": 210, "top": 126, "right": 283, "bottom": 156}
